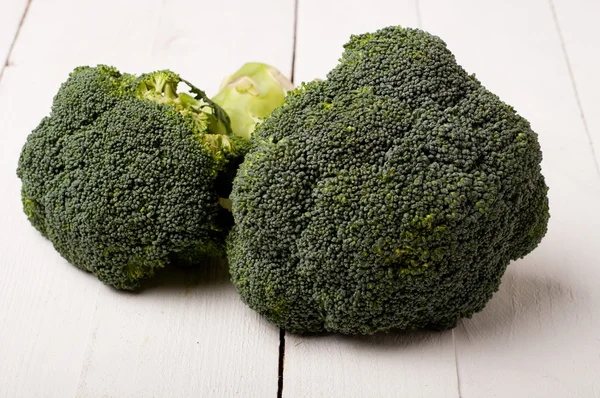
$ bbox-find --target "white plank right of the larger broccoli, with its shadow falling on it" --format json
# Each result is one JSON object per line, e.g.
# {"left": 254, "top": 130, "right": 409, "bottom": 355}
{"left": 421, "top": 0, "right": 600, "bottom": 398}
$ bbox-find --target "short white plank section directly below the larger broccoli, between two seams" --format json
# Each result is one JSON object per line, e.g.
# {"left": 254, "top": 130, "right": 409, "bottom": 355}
{"left": 283, "top": 331, "right": 459, "bottom": 398}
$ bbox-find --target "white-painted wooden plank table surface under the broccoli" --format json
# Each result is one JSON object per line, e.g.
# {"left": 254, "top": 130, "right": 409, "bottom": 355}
{"left": 0, "top": 0, "right": 600, "bottom": 398}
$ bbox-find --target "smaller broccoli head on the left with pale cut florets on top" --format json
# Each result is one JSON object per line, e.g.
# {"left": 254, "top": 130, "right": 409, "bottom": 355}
{"left": 17, "top": 66, "right": 238, "bottom": 289}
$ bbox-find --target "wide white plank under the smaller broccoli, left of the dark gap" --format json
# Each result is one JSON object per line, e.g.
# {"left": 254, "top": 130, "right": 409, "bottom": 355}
{"left": 0, "top": 0, "right": 294, "bottom": 397}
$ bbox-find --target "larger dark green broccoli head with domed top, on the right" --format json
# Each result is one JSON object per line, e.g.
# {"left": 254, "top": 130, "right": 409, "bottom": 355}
{"left": 227, "top": 27, "right": 549, "bottom": 334}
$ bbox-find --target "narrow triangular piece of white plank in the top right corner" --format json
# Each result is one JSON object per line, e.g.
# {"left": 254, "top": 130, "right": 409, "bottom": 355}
{"left": 551, "top": 0, "right": 600, "bottom": 174}
